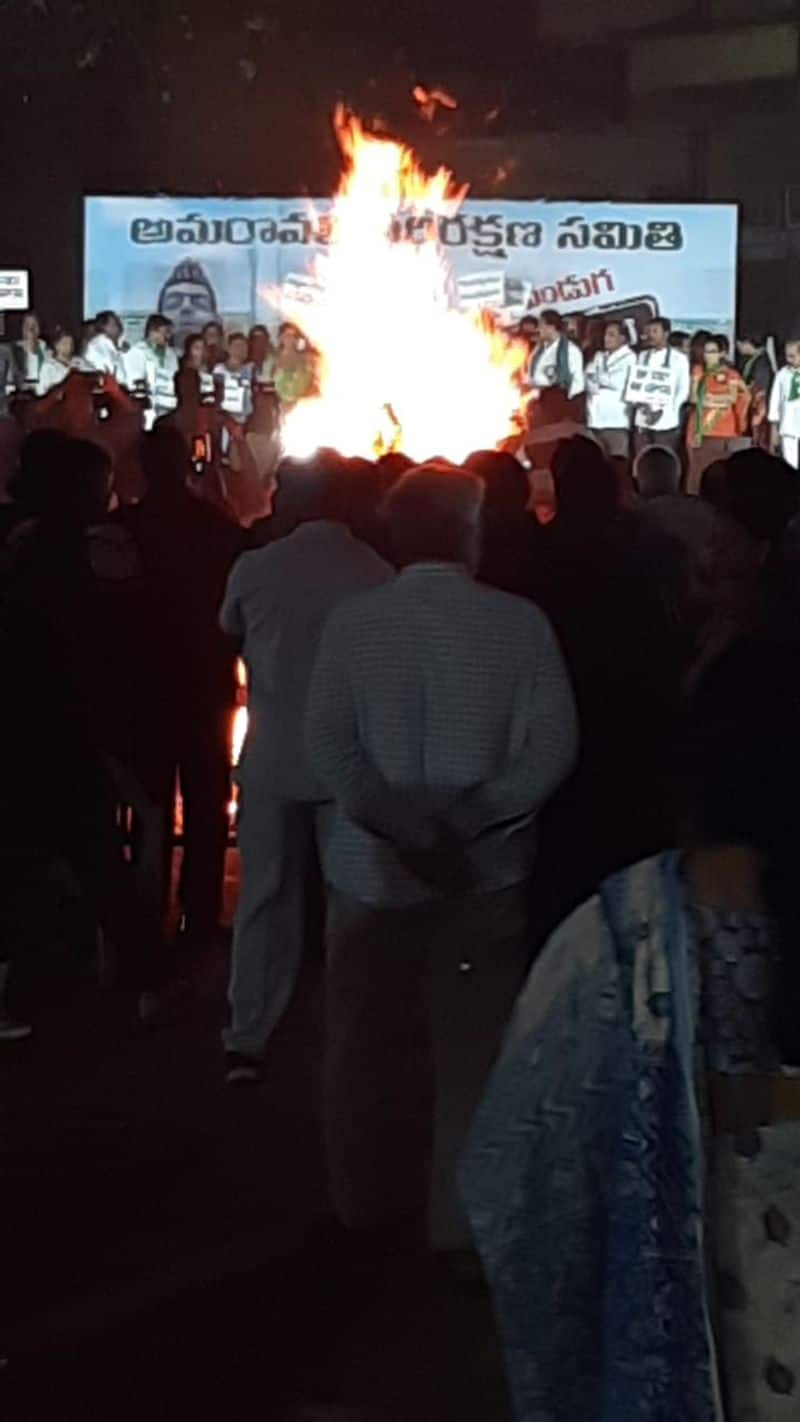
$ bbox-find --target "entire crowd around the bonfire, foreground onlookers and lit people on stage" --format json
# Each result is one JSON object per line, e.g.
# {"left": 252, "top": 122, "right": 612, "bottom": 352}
{"left": 0, "top": 297, "right": 800, "bottom": 1422}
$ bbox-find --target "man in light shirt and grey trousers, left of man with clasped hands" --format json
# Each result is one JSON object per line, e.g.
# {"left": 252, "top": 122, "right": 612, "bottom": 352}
{"left": 220, "top": 458, "right": 394, "bottom": 1084}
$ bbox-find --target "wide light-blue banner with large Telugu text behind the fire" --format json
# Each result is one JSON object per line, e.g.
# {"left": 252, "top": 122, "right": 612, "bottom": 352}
{"left": 84, "top": 198, "right": 737, "bottom": 344}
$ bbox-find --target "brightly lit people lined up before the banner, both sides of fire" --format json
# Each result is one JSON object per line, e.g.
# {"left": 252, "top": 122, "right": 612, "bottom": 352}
{"left": 0, "top": 302, "right": 800, "bottom": 503}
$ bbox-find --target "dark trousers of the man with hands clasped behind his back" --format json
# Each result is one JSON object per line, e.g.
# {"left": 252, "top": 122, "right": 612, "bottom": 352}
{"left": 324, "top": 886, "right": 529, "bottom": 1249}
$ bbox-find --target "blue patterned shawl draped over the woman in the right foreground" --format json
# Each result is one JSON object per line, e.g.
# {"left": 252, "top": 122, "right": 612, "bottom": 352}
{"left": 462, "top": 855, "right": 722, "bottom": 1422}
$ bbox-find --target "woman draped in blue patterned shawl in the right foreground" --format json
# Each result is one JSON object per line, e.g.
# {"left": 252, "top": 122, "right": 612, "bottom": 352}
{"left": 463, "top": 641, "right": 800, "bottom": 1422}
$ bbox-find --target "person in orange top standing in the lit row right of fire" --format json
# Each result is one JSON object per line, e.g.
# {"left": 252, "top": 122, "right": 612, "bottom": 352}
{"left": 686, "top": 336, "right": 750, "bottom": 493}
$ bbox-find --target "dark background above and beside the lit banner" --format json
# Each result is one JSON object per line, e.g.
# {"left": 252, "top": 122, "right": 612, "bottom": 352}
{"left": 0, "top": 0, "right": 800, "bottom": 330}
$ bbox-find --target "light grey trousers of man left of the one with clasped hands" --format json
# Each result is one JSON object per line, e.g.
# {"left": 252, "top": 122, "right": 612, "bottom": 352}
{"left": 223, "top": 786, "right": 317, "bottom": 1057}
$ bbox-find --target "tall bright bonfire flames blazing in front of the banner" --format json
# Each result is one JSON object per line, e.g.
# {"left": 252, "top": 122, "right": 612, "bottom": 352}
{"left": 283, "top": 108, "right": 526, "bottom": 462}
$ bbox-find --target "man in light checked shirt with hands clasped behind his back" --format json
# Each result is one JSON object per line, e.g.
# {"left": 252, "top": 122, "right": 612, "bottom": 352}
{"left": 305, "top": 465, "right": 578, "bottom": 1249}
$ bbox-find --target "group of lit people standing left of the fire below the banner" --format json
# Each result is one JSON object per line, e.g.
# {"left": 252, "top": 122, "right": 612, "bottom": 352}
{"left": 0, "top": 311, "right": 318, "bottom": 523}
